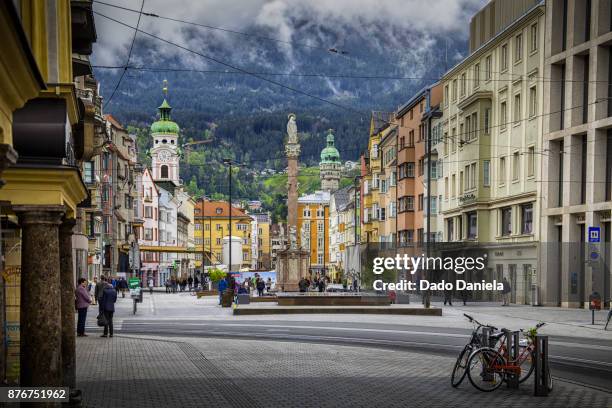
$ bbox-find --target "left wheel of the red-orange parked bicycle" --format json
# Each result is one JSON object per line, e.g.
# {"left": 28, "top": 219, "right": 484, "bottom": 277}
{"left": 467, "top": 348, "right": 506, "bottom": 392}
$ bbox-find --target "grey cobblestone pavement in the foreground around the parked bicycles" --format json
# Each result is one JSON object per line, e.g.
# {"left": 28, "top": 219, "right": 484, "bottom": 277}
{"left": 77, "top": 335, "right": 612, "bottom": 408}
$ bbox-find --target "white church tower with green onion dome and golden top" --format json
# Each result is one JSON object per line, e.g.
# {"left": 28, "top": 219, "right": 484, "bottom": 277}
{"left": 151, "top": 80, "right": 180, "bottom": 186}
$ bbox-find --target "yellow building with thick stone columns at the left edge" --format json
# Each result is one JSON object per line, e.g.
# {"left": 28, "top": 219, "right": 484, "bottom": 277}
{"left": 0, "top": 0, "right": 96, "bottom": 388}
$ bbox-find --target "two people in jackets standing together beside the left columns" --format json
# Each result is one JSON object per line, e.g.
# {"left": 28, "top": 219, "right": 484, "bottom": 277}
{"left": 74, "top": 276, "right": 117, "bottom": 337}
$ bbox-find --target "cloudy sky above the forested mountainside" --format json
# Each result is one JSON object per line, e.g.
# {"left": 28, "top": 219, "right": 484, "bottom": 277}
{"left": 92, "top": 0, "right": 487, "bottom": 68}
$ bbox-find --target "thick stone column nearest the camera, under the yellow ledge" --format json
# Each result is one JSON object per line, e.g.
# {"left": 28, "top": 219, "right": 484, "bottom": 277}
{"left": 13, "top": 205, "right": 64, "bottom": 394}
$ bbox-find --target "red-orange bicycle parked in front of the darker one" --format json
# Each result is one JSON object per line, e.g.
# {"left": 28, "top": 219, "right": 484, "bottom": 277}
{"left": 467, "top": 323, "right": 552, "bottom": 392}
